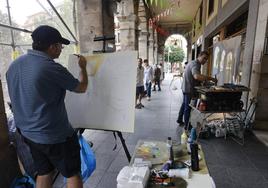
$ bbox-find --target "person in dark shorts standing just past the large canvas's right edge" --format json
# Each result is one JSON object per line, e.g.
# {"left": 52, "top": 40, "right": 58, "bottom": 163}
{"left": 135, "top": 58, "right": 144, "bottom": 109}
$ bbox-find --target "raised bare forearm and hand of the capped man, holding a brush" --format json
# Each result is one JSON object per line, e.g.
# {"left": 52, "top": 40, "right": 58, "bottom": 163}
{"left": 74, "top": 56, "right": 88, "bottom": 93}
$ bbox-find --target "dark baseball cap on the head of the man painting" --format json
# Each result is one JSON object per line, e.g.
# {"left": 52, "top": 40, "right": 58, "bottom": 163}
{"left": 31, "top": 25, "right": 70, "bottom": 45}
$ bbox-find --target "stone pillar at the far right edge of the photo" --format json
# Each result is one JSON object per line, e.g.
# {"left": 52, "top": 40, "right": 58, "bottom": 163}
{"left": 247, "top": 0, "right": 268, "bottom": 131}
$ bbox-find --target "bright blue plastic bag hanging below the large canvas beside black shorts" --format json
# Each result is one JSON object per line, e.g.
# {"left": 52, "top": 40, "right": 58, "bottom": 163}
{"left": 79, "top": 135, "right": 96, "bottom": 182}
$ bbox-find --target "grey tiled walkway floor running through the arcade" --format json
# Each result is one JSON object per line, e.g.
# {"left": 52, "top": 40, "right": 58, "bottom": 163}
{"left": 54, "top": 77, "right": 268, "bottom": 188}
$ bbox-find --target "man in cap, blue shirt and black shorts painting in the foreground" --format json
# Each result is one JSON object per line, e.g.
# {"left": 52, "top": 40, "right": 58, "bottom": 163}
{"left": 6, "top": 25, "right": 88, "bottom": 188}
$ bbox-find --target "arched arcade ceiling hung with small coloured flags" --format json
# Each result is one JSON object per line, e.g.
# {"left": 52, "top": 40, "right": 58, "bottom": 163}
{"left": 144, "top": 0, "right": 201, "bottom": 52}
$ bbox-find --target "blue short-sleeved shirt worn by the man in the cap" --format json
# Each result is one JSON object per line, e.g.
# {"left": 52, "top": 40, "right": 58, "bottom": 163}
{"left": 6, "top": 50, "right": 79, "bottom": 144}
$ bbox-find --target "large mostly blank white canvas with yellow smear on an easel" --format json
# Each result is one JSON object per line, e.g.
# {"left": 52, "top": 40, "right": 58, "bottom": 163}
{"left": 65, "top": 51, "right": 137, "bottom": 132}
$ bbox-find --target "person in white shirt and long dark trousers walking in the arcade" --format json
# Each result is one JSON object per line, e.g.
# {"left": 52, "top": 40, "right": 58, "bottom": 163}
{"left": 144, "top": 59, "right": 153, "bottom": 101}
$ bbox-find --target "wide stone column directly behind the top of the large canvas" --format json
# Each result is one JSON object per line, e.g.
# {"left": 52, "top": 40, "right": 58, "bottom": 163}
{"left": 77, "top": 0, "right": 116, "bottom": 54}
